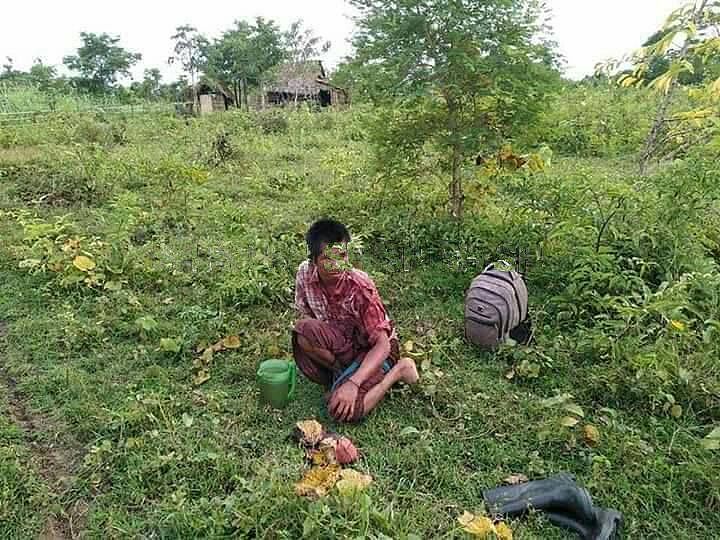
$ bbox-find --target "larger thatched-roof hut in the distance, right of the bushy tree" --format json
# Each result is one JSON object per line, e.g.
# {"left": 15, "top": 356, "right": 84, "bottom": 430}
{"left": 263, "top": 60, "right": 348, "bottom": 107}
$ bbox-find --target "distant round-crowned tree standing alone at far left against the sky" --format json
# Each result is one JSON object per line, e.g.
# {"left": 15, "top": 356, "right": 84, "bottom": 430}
{"left": 63, "top": 32, "right": 142, "bottom": 92}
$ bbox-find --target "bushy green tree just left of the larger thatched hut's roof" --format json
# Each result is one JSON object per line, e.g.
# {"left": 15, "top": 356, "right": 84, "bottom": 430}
{"left": 204, "top": 17, "right": 283, "bottom": 108}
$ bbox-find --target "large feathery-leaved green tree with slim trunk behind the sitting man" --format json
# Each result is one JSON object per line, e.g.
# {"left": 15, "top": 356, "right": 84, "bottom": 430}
{"left": 350, "top": 0, "right": 556, "bottom": 217}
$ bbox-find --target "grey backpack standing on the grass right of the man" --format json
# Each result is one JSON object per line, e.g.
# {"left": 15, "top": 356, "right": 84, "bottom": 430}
{"left": 465, "top": 261, "right": 528, "bottom": 350}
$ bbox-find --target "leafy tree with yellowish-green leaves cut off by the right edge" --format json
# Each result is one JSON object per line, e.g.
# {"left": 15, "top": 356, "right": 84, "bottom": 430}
{"left": 599, "top": 0, "right": 720, "bottom": 174}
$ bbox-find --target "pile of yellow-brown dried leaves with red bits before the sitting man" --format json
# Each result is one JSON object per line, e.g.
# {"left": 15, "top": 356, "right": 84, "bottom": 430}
{"left": 293, "top": 420, "right": 372, "bottom": 498}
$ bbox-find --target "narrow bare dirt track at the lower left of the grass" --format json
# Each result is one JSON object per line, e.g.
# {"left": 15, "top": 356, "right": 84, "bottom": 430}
{"left": 0, "top": 321, "right": 87, "bottom": 540}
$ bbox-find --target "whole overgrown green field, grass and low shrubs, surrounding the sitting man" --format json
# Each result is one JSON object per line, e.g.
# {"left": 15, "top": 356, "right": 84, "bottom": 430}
{"left": 0, "top": 103, "right": 720, "bottom": 539}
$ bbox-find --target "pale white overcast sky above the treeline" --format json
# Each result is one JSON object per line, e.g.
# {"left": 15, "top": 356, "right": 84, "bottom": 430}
{"left": 0, "top": 0, "right": 685, "bottom": 83}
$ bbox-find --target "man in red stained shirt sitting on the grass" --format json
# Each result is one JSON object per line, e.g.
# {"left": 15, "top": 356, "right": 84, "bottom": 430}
{"left": 292, "top": 220, "right": 418, "bottom": 422}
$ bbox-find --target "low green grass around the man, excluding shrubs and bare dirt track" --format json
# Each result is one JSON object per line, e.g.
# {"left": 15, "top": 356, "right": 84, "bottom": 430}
{"left": 0, "top": 107, "right": 720, "bottom": 539}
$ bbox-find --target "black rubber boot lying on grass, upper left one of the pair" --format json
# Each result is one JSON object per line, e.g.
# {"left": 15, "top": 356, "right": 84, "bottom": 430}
{"left": 483, "top": 473, "right": 596, "bottom": 525}
